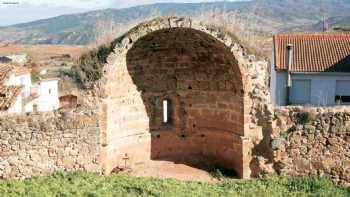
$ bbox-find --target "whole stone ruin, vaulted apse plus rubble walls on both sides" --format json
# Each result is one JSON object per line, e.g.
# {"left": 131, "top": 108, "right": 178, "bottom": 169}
{"left": 0, "top": 17, "right": 350, "bottom": 184}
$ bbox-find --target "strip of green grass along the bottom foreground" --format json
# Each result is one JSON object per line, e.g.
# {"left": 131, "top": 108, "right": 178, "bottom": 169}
{"left": 0, "top": 172, "right": 350, "bottom": 197}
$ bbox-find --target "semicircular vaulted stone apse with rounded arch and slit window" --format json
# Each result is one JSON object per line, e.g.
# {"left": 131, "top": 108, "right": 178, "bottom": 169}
{"left": 100, "top": 18, "right": 266, "bottom": 178}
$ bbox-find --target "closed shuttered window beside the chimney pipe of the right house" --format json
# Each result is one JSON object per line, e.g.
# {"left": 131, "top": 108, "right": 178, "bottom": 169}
{"left": 290, "top": 79, "right": 311, "bottom": 105}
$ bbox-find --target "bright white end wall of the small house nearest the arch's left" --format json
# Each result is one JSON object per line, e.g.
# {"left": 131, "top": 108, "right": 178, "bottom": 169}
{"left": 33, "top": 80, "right": 59, "bottom": 111}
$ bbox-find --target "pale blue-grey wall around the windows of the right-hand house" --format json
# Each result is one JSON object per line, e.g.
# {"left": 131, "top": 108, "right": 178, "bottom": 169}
{"left": 271, "top": 71, "right": 350, "bottom": 106}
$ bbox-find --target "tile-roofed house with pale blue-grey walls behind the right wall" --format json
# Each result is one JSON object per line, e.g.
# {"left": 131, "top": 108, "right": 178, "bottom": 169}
{"left": 271, "top": 33, "right": 350, "bottom": 106}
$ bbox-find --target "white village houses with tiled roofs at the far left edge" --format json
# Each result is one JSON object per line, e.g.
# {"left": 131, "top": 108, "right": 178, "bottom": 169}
{"left": 0, "top": 64, "right": 59, "bottom": 113}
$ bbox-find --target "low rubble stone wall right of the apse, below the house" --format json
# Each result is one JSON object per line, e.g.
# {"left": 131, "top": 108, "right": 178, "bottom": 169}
{"left": 271, "top": 107, "right": 350, "bottom": 184}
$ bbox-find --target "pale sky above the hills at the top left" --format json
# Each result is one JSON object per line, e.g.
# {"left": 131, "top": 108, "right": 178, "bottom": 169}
{"left": 0, "top": 0, "right": 239, "bottom": 26}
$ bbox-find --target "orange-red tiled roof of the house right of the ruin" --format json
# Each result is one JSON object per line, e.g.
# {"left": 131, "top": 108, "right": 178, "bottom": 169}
{"left": 274, "top": 33, "right": 350, "bottom": 72}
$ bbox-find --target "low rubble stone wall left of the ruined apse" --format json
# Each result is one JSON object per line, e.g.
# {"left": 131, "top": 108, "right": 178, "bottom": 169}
{"left": 0, "top": 111, "right": 100, "bottom": 179}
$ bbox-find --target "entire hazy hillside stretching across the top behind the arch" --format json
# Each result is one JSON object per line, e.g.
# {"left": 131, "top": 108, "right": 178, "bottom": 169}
{"left": 0, "top": 0, "right": 350, "bottom": 45}
